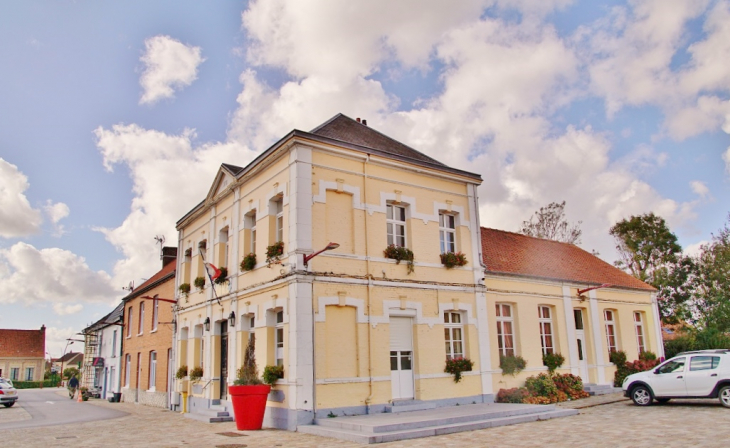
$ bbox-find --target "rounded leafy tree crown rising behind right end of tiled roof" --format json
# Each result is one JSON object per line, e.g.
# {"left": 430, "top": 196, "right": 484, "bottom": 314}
{"left": 609, "top": 213, "right": 682, "bottom": 286}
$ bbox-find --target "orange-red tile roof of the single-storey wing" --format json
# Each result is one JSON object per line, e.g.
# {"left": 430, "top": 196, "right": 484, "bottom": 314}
{"left": 482, "top": 227, "right": 655, "bottom": 291}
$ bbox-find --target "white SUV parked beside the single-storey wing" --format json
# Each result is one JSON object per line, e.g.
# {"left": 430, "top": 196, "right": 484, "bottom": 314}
{"left": 621, "top": 350, "right": 730, "bottom": 408}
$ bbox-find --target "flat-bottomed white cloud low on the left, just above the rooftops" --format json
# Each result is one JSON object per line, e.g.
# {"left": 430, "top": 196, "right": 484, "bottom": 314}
{"left": 0, "top": 242, "right": 119, "bottom": 305}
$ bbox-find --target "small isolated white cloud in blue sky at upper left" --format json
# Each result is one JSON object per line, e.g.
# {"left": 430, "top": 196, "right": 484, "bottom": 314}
{"left": 139, "top": 36, "right": 205, "bottom": 104}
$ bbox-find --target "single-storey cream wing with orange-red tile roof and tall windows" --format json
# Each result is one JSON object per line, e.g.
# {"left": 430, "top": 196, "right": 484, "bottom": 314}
{"left": 481, "top": 228, "right": 664, "bottom": 390}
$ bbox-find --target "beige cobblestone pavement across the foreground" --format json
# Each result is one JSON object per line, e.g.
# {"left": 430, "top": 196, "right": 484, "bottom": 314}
{"left": 2, "top": 394, "right": 730, "bottom": 448}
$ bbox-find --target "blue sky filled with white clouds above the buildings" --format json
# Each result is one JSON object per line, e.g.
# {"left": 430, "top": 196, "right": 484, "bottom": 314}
{"left": 0, "top": 0, "right": 730, "bottom": 357}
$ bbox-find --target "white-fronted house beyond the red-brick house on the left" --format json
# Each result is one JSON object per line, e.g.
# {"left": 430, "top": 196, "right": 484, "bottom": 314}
{"left": 81, "top": 303, "right": 124, "bottom": 399}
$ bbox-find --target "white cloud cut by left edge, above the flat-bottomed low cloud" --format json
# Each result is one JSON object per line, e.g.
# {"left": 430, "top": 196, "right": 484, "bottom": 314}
{"left": 0, "top": 158, "right": 42, "bottom": 238}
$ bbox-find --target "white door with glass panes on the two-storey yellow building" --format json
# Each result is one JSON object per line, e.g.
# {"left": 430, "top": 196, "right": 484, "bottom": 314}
{"left": 390, "top": 317, "right": 413, "bottom": 400}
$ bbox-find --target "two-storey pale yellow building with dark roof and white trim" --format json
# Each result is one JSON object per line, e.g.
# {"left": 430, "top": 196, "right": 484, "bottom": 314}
{"left": 173, "top": 115, "right": 486, "bottom": 430}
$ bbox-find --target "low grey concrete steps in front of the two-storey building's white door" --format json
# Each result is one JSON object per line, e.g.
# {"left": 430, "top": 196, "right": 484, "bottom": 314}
{"left": 297, "top": 406, "right": 578, "bottom": 444}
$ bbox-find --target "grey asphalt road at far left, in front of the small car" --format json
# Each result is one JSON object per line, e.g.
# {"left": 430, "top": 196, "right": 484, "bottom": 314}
{"left": 0, "top": 388, "right": 128, "bottom": 431}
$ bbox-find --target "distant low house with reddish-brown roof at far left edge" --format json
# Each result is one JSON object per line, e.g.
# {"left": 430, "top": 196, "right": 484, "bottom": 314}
{"left": 0, "top": 325, "right": 46, "bottom": 381}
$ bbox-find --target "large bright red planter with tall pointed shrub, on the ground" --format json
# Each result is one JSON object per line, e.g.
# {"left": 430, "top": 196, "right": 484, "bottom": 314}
{"left": 228, "top": 335, "right": 268, "bottom": 431}
